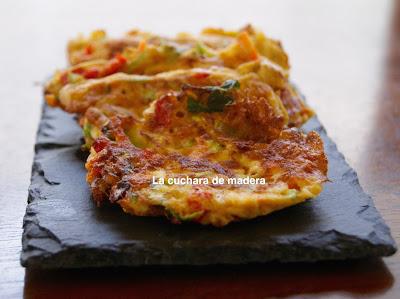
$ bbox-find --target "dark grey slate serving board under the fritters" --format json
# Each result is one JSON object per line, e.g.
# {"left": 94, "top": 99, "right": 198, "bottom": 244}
{"left": 21, "top": 105, "right": 396, "bottom": 268}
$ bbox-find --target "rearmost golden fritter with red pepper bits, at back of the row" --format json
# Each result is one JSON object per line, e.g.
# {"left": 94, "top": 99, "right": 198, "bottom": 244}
{"left": 45, "top": 26, "right": 313, "bottom": 126}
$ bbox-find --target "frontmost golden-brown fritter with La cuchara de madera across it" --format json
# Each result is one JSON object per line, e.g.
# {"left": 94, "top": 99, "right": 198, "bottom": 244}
{"left": 86, "top": 119, "right": 327, "bottom": 226}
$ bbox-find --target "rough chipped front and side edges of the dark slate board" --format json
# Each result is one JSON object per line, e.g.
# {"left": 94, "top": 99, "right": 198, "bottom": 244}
{"left": 21, "top": 104, "right": 397, "bottom": 268}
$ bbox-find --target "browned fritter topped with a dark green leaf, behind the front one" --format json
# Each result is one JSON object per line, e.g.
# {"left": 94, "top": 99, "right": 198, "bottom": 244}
{"left": 82, "top": 77, "right": 288, "bottom": 151}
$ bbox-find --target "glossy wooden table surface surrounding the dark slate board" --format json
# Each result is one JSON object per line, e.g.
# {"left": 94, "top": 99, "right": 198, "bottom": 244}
{"left": 0, "top": 0, "right": 400, "bottom": 298}
